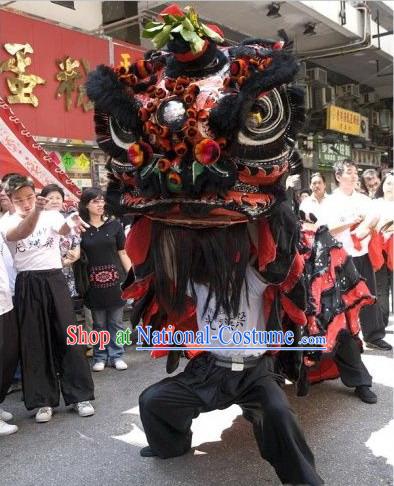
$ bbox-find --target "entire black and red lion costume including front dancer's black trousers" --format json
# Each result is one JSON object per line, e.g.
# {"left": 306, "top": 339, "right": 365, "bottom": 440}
{"left": 87, "top": 5, "right": 371, "bottom": 484}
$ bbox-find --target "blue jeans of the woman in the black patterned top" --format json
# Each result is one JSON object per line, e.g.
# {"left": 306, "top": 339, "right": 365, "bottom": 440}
{"left": 92, "top": 306, "right": 124, "bottom": 363}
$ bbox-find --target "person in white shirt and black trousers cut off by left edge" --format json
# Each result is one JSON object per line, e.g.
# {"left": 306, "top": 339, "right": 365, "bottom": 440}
{"left": 0, "top": 234, "right": 18, "bottom": 436}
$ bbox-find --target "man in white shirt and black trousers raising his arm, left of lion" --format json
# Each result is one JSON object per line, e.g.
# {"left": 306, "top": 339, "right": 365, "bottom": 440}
{"left": 2, "top": 176, "right": 94, "bottom": 422}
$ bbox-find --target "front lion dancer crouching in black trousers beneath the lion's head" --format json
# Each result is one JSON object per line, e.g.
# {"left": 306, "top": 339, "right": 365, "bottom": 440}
{"left": 140, "top": 225, "right": 323, "bottom": 485}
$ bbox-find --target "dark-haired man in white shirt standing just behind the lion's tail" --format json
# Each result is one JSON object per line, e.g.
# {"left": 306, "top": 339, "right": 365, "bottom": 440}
{"left": 318, "top": 160, "right": 392, "bottom": 351}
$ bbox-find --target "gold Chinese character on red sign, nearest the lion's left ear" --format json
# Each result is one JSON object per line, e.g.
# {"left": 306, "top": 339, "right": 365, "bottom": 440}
{"left": 56, "top": 56, "right": 93, "bottom": 111}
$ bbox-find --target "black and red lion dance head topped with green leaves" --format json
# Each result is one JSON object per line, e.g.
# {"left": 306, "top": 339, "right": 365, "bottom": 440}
{"left": 86, "top": 5, "right": 304, "bottom": 226}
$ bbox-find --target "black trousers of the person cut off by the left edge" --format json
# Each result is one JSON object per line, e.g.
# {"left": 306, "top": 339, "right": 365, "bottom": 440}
{"left": 0, "top": 310, "right": 19, "bottom": 403}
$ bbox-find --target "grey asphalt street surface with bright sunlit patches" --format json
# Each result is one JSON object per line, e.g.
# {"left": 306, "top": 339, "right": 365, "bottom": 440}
{"left": 0, "top": 321, "right": 394, "bottom": 486}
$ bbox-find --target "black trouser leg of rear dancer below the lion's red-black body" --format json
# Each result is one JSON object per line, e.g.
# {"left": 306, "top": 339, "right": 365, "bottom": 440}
{"left": 334, "top": 332, "right": 372, "bottom": 388}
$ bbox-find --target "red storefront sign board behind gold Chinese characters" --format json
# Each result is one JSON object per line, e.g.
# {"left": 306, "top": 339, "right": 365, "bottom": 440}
{"left": 0, "top": 10, "right": 143, "bottom": 140}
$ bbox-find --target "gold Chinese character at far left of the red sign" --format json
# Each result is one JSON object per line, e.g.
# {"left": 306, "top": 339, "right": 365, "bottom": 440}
{"left": 0, "top": 44, "right": 45, "bottom": 108}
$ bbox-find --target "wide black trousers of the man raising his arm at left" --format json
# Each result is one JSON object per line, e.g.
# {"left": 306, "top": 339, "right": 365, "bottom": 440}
{"left": 15, "top": 270, "right": 94, "bottom": 410}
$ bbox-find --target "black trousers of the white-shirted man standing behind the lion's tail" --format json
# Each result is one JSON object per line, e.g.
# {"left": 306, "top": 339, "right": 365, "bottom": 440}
{"left": 353, "top": 254, "right": 386, "bottom": 343}
